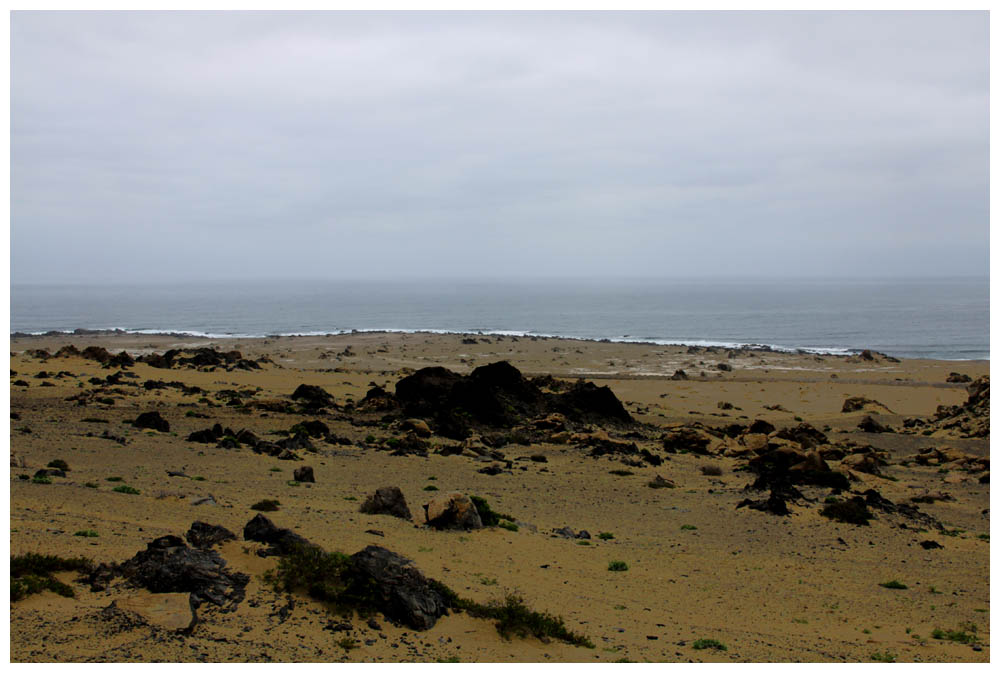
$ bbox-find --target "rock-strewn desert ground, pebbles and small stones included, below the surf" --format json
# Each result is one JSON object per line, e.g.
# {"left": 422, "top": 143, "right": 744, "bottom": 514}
{"left": 10, "top": 333, "right": 990, "bottom": 662}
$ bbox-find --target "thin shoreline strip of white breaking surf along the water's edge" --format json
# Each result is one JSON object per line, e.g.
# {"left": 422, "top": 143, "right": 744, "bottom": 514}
{"left": 10, "top": 328, "right": 990, "bottom": 363}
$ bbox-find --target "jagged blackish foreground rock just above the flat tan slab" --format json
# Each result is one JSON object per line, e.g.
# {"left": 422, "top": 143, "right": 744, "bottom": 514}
{"left": 116, "top": 535, "right": 250, "bottom": 610}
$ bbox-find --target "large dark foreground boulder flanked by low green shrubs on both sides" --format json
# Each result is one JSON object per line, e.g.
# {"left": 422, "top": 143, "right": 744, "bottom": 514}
{"left": 351, "top": 545, "right": 449, "bottom": 631}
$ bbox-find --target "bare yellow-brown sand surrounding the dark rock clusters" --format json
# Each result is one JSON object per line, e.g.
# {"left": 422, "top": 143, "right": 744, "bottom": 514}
{"left": 10, "top": 333, "right": 989, "bottom": 662}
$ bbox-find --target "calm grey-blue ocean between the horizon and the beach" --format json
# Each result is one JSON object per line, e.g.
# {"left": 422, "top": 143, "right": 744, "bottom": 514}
{"left": 10, "top": 279, "right": 990, "bottom": 360}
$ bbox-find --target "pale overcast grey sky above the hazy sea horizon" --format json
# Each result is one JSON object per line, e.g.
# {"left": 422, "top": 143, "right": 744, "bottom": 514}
{"left": 10, "top": 12, "right": 989, "bottom": 284}
